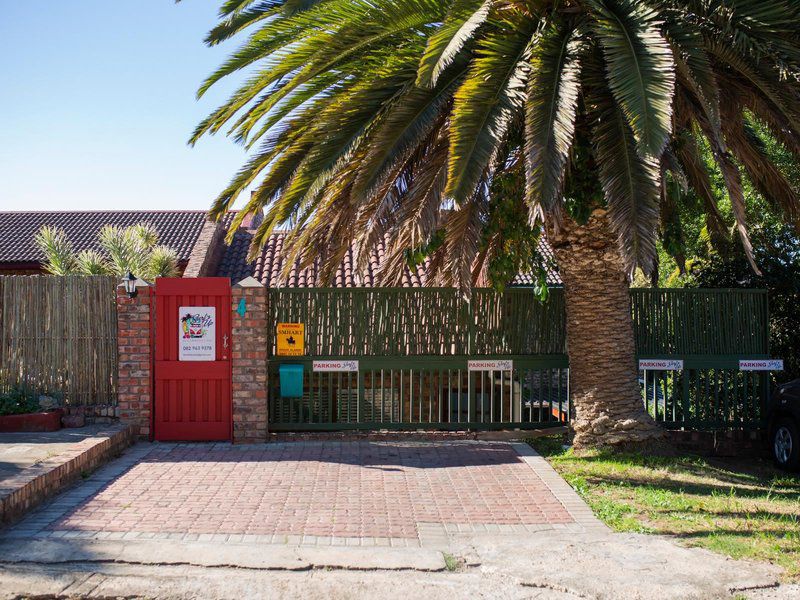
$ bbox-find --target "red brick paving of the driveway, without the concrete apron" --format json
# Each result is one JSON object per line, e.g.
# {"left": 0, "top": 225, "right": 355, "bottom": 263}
{"left": 14, "top": 442, "right": 573, "bottom": 541}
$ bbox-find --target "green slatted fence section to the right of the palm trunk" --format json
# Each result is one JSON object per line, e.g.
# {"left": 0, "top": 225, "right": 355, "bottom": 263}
{"left": 631, "top": 289, "right": 771, "bottom": 430}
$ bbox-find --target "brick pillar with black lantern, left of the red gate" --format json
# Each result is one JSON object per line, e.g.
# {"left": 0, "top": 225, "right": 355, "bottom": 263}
{"left": 117, "top": 280, "right": 153, "bottom": 437}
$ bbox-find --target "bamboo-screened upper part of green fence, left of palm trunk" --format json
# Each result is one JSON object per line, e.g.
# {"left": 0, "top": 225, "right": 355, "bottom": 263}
{"left": 268, "top": 288, "right": 566, "bottom": 357}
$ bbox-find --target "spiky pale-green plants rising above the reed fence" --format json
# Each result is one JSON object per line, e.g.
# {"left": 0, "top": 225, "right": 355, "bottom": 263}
{"left": 35, "top": 223, "right": 178, "bottom": 280}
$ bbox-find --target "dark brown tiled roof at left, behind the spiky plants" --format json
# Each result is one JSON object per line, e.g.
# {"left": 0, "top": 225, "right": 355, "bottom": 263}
{"left": 0, "top": 210, "right": 212, "bottom": 263}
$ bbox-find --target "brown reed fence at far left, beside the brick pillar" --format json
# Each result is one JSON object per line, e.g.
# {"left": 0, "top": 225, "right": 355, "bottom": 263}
{"left": 0, "top": 276, "right": 117, "bottom": 405}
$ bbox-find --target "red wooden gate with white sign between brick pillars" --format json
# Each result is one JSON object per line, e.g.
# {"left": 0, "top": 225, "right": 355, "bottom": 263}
{"left": 153, "top": 277, "right": 232, "bottom": 441}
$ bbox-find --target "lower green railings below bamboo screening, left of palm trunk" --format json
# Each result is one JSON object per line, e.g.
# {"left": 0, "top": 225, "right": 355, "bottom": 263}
{"left": 269, "top": 356, "right": 570, "bottom": 431}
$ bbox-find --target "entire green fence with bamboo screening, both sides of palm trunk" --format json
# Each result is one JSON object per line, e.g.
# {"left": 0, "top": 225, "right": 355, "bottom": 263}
{"left": 268, "top": 288, "right": 769, "bottom": 431}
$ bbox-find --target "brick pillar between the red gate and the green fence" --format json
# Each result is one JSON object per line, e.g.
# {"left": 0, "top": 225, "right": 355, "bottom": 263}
{"left": 231, "top": 277, "right": 267, "bottom": 444}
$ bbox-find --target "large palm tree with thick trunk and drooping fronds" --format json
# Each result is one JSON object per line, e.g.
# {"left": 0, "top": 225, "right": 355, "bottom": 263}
{"left": 191, "top": 0, "right": 800, "bottom": 447}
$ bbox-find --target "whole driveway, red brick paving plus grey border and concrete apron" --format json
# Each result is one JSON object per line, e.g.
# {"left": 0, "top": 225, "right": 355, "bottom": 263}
{"left": 0, "top": 441, "right": 797, "bottom": 600}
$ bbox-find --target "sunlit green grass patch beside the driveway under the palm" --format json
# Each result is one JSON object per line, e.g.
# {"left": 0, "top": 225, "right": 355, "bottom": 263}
{"left": 530, "top": 436, "right": 800, "bottom": 581}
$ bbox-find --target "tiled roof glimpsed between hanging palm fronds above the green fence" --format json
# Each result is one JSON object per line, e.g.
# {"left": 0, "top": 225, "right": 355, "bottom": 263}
{"left": 217, "top": 229, "right": 561, "bottom": 288}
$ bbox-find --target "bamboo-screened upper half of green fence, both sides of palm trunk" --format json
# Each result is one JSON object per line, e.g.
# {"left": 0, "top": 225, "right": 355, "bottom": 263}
{"left": 269, "top": 288, "right": 769, "bottom": 357}
